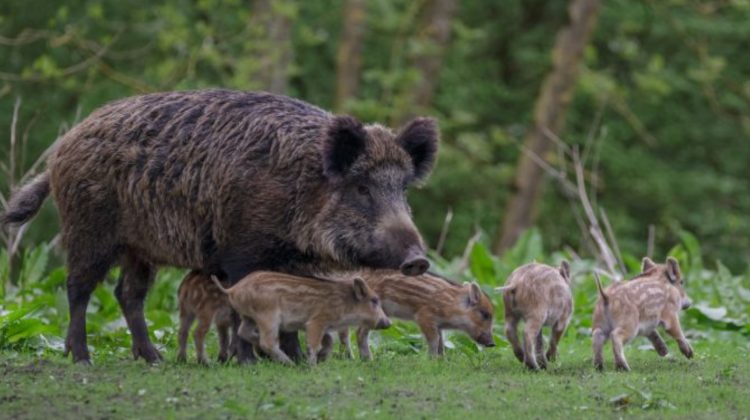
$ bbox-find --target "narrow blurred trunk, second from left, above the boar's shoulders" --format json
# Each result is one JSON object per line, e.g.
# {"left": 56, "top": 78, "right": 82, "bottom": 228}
{"left": 336, "top": 0, "right": 366, "bottom": 111}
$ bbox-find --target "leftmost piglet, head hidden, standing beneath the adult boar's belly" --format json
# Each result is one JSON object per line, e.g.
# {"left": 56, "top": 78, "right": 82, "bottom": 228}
{"left": 177, "top": 271, "right": 232, "bottom": 364}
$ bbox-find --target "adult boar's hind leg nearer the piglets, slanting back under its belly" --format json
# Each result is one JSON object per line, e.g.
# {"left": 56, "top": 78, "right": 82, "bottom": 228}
{"left": 115, "top": 251, "right": 162, "bottom": 363}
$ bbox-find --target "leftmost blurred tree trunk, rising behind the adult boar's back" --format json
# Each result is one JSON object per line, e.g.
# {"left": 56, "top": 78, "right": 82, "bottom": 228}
{"left": 250, "top": 0, "right": 296, "bottom": 93}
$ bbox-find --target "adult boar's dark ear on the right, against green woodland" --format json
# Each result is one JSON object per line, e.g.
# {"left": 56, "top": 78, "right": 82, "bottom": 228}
{"left": 396, "top": 117, "right": 439, "bottom": 182}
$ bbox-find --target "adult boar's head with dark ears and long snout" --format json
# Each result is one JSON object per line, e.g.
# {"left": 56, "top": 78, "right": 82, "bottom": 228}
{"left": 311, "top": 116, "right": 438, "bottom": 276}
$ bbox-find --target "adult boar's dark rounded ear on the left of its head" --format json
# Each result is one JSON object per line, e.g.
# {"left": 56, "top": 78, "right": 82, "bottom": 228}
{"left": 323, "top": 115, "right": 367, "bottom": 178}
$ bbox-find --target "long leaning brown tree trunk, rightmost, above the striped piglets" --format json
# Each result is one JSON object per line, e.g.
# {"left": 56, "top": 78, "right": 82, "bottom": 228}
{"left": 494, "top": 0, "right": 600, "bottom": 254}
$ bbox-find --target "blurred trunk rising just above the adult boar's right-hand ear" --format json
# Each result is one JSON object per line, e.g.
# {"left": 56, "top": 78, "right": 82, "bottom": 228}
{"left": 398, "top": 0, "right": 458, "bottom": 122}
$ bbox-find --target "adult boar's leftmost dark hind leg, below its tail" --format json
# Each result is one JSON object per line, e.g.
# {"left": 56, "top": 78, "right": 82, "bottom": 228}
{"left": 65, "top": 248, "right": 114, "bottom": 364}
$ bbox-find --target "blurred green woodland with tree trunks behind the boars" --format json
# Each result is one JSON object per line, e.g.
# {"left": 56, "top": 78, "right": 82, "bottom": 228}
{"left": 0, "top": 0, "right": 750, "bottom": 271}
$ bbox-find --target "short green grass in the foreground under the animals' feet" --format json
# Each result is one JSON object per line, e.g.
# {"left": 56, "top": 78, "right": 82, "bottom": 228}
{"left": 0, "top": 334, "right": 750, "bottom": 418}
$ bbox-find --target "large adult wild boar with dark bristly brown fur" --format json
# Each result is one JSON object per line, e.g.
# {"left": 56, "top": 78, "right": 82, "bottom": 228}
{"left": 0, "top": 90, "right": 438, "bottom": 362}
